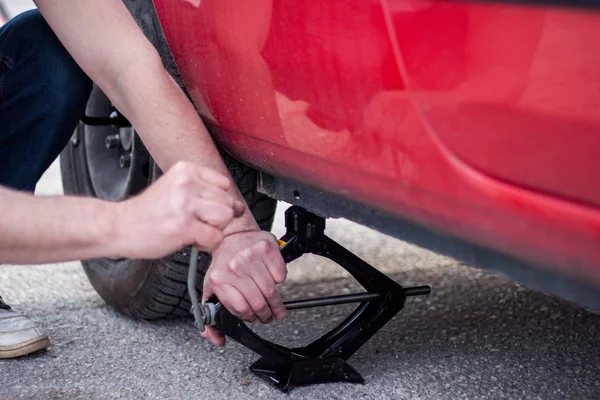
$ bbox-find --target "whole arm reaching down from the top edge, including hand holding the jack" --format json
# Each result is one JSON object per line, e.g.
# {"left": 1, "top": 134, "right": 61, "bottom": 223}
{"left": 35, "top": 0, "right": 287, "bottom": 344}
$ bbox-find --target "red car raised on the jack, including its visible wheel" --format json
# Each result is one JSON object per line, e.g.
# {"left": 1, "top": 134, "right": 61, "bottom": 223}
{"left": 62, "top": 0, "right": 600, "bottom": 318}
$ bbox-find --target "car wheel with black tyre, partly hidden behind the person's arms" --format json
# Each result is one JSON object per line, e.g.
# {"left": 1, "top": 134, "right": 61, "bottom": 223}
{"left": 60, "top": 87, "right": 276, "bottom": 319}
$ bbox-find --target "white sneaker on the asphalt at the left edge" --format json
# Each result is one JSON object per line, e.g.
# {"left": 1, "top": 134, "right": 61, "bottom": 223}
{"left": 0, "top": 297, "right": 50, "bottom": 358}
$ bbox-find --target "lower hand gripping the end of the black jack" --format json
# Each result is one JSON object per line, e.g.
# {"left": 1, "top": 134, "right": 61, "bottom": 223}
{"left": 203, "top": 231, "right": 287, "bottom": 346}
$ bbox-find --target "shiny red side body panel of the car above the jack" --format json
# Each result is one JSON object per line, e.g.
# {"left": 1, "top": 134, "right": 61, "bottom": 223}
{"left": 154, "top": 0, "right": 600, "bottom": 284}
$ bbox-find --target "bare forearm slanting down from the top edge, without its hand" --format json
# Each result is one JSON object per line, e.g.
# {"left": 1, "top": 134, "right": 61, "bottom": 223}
{"left": 36, "top": 0, "right": 258, "bottom": 234}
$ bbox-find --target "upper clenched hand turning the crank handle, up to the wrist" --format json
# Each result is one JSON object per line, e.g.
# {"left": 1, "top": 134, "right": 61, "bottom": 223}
{"left": 116, "top": 162, "right": 245, "bottom": 259}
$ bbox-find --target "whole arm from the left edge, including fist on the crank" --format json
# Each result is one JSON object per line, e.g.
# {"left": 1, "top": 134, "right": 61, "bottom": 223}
{"left": 0, "top": 163, "right": 244, "bottom": 264}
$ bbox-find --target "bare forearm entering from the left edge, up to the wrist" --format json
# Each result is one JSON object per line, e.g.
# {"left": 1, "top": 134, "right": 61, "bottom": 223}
{"left": 0, "top": 187, "right": 118, "bottom": 264}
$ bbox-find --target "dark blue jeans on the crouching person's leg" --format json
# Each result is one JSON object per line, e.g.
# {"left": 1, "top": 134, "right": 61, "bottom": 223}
{"left": 0, "top": 10, "right": 92, "bottom": 191}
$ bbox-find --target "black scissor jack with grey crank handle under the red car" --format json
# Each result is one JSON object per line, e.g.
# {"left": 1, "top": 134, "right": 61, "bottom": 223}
{"left": 188, "top": 206, "right": 431, "bottom": 392}
